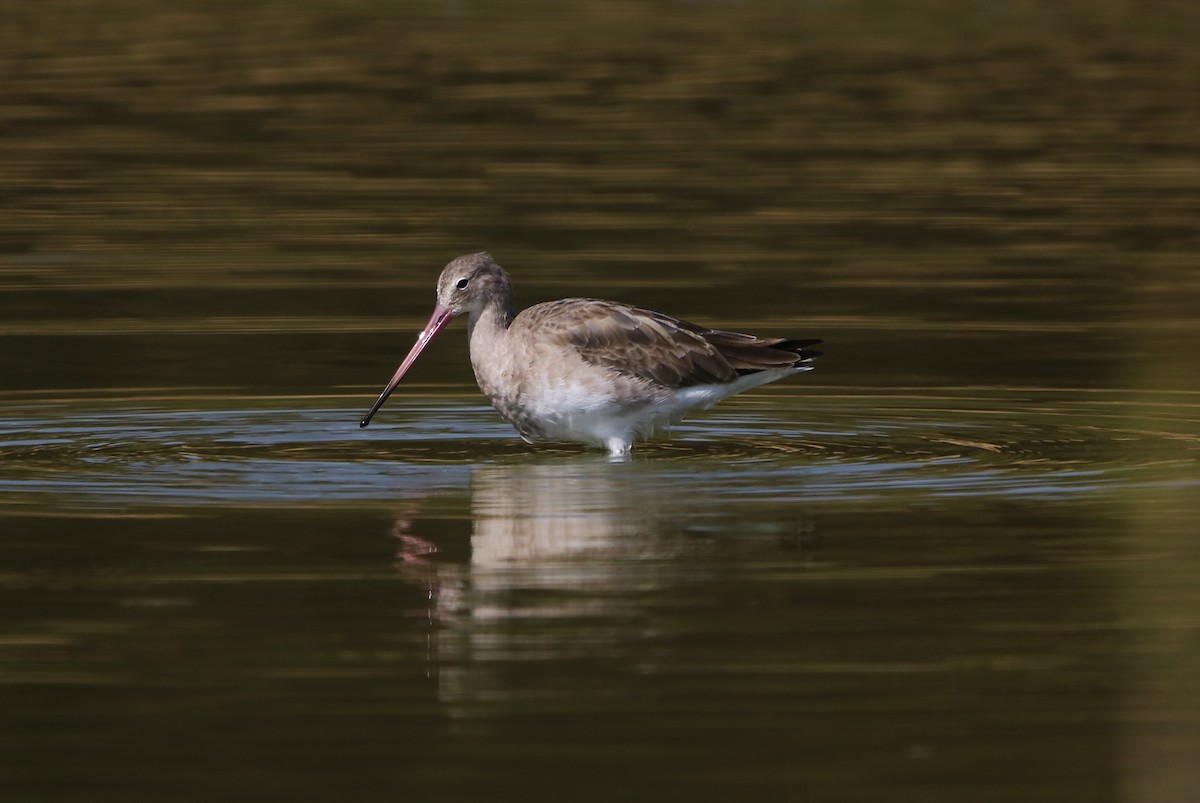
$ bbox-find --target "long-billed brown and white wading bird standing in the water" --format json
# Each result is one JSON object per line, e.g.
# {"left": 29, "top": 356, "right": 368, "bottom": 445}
{"left": 359, "top": 252, "right": 822, "bottom": 457}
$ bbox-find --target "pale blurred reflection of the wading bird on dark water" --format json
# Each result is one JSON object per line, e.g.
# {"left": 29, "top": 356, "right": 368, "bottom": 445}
{"left": 395, "top": 457, "right": 810, "bottom": 718}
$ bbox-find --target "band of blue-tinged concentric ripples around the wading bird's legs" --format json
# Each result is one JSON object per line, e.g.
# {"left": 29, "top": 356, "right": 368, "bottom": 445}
{"left": 0, "top": 390, "right": 1200, "bottom": 510}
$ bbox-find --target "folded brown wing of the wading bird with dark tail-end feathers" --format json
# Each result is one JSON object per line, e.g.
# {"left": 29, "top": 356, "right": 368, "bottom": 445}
{"left": 514, "top": 299, "right": 816, "bottom": 388}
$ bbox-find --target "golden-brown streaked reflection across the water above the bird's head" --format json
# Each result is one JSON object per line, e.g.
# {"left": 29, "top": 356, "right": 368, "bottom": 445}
{"left": 0, "top": 0, "right": 1200, "bottom": 283}
